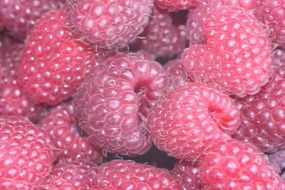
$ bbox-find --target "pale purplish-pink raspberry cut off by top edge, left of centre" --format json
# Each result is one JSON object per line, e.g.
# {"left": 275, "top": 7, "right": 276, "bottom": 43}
{"left": 67, "top": 0, "right": 154, "bottom": 49}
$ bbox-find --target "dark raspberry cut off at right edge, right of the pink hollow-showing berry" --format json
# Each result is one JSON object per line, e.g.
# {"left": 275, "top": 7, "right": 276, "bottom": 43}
{"left": 234, "top": 51, "right": 285, "bottom": 152}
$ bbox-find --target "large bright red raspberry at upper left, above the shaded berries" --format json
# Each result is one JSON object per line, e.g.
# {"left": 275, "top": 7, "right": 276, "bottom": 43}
{"left": 19, "top": 9, "right": 95, "bottom": 105}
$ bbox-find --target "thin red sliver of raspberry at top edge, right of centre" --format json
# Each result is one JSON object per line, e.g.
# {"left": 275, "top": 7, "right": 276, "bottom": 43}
{"left": 155, "top": 0, "right": 201, "bottom": 12}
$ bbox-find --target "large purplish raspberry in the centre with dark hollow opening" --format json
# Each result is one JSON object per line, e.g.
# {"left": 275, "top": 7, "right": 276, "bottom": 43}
{"left": 74, "top": 53, "right": 168, "bottom": 155}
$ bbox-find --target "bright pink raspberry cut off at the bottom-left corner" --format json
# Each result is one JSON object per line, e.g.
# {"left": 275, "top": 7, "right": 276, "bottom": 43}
{"left": 0, "top": 116, "right": 55, "bottom": 190}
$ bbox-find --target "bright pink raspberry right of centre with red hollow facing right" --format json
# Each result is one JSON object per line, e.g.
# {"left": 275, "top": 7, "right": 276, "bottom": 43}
{"left": 148, "top": 83, "right": 240, "bottom": 161}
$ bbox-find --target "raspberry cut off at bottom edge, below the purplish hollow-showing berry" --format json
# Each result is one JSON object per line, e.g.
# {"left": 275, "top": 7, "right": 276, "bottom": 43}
{"left": 93, "top": 160, "right": 182, "bottom": 190}
